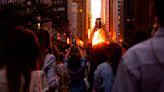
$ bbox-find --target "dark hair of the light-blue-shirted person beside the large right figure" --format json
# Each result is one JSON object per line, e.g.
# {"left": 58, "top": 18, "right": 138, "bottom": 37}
{"left": 108, "top": 42, "right": 122, "bottom": 75}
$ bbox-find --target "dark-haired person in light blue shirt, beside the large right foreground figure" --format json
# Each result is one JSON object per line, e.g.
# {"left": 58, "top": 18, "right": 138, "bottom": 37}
{"left": 93, "top": 43, "right": 122, "bottom": 92}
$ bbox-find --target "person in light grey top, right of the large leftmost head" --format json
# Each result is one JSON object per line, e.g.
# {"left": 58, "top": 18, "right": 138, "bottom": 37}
{"left": 36, "top": 29, "right": 59, "bottom": 92}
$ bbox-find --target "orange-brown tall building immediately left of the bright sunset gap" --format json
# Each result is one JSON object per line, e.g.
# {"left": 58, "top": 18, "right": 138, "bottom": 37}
{"left": 67, "top": 0, "right": 88, "bottom": 42}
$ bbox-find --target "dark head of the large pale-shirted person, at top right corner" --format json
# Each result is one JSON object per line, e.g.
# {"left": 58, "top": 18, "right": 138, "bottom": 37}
{"left": 154, "top": 0, "right": 164, "bottom": 26}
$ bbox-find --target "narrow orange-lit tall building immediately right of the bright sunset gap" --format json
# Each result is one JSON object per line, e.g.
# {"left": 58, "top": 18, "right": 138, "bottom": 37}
{"left": 109, "top": 0, "right": 124, "bottom": 42}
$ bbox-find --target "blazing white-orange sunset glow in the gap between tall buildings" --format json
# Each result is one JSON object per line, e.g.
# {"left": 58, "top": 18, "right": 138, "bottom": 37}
{"left": 87, "top": 0, "right": 113, "bottom": 42}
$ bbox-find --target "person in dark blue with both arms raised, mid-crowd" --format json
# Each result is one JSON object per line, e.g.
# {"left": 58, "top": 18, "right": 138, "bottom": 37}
{"left": 64, "top": 46, "right": 86, "bottom": 92}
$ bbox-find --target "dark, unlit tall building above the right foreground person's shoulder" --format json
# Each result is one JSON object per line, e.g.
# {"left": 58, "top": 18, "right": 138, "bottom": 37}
{"left": 121, "top": 0, "right": 154, "bottom": 38}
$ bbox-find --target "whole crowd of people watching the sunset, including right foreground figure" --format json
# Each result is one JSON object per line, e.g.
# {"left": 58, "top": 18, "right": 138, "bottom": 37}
{"left": 0, "top": 0, "right": 164, "bottom": 92}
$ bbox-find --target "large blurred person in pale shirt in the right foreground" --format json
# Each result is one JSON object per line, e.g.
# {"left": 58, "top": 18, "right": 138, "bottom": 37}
{"left": 112, "top": 0, "right": 164, "bottom": 92}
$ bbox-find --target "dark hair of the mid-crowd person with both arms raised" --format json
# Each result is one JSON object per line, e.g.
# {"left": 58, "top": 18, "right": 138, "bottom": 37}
{"left": 68, "top": 46, "right": 81, "bottom": 71}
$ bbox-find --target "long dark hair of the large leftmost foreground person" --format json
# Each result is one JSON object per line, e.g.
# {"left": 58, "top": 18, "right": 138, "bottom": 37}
{"left": 5, "top": 27, "right": 38, "bottom": 92}
